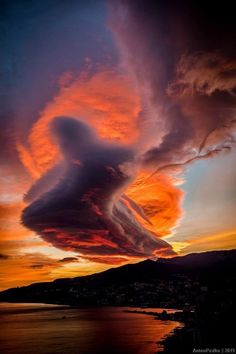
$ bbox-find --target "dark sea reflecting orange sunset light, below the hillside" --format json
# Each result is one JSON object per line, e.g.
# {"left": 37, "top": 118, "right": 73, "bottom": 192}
{"left": 0, "top": 303, "right": 181, "bottom": 354}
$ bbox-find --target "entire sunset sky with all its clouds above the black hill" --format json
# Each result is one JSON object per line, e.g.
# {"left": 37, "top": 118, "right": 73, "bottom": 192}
{"left": 0, "top": 0, "right": 236, "bottom": 289}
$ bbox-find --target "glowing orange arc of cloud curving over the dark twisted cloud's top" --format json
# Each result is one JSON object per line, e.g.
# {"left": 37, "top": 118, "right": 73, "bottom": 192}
{"left": 17, "top": 71, "right": 141, "bottom": 179}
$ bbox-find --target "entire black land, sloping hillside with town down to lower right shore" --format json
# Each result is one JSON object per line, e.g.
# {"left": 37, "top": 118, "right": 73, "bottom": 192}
{"left": 0, "top": 250, "right": 236, "bottom": 354}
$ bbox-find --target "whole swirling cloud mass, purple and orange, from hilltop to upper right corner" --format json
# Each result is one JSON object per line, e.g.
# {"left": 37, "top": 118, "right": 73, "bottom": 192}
{"left": 21, "top": 0, "right": 236, "bottom": 263}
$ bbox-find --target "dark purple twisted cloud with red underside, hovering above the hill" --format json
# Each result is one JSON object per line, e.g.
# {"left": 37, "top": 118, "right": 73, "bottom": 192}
{"left": 22, "top": 117, "right": 173, "bottom": 261}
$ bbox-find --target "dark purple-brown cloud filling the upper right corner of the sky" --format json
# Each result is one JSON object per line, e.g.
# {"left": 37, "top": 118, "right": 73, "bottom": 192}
{"left": 110, "top": 0, "right": 236, "bottom": 169}
